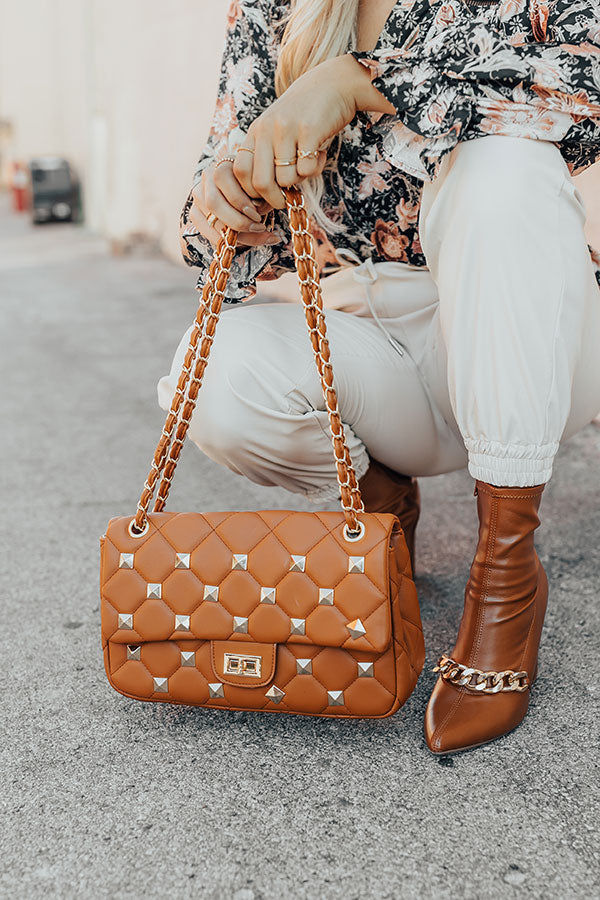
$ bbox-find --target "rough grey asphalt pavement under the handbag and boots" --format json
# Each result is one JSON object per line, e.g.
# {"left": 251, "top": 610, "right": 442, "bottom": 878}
{"left": 0, "top": 199, "right": 600, "bottom": 900}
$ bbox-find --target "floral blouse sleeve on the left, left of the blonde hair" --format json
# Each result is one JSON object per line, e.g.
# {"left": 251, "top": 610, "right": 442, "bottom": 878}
{"left": 179, "top": 0, "right": 294, "bottom": 302}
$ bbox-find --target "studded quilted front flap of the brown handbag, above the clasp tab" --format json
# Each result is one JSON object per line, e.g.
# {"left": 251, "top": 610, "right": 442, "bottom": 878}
{"left": 101, "top": 510, "right": 395, "bottom": 653}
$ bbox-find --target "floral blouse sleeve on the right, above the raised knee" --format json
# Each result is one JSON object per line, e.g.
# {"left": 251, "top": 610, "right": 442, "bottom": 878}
{"left": 353, "top": 0, "right": 600, "bottom": 180}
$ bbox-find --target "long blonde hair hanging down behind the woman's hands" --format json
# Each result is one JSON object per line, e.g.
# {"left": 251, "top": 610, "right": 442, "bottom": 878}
{"left": 275, "top": 0, "right": 360, "bottom": 234}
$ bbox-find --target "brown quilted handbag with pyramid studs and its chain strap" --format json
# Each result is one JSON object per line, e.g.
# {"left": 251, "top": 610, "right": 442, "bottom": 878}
{"left": 100, "top": 188, "right": 424, "bottom": 718}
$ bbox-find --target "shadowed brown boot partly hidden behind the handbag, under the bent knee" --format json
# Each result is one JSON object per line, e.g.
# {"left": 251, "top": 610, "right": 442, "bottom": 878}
{"left": 359, "top": 459, "right": 421, "bottom": 574}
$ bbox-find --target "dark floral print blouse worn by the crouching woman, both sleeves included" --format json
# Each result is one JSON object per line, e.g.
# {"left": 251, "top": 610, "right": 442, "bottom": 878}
{"left": 181, "top": 0, "right": 600, "bottom": 302}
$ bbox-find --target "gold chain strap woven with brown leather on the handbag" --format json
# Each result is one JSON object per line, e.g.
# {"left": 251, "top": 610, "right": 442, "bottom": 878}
{"left": 129, "top": 187, "right": 364, "bottom": 535}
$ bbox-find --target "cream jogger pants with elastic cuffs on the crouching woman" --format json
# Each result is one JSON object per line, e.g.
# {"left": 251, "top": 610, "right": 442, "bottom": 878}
{"left": 158, "top": 136, "right": 600, "bottom": 501}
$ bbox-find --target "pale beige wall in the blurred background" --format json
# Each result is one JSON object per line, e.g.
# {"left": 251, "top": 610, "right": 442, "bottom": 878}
{"left": 0, "top": 0, "right": 600, "bottom": 259}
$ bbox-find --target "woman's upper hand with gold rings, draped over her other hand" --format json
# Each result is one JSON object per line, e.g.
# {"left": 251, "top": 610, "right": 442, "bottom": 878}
{"left": 233, "top": 55, "right": 396, "bottom": 209}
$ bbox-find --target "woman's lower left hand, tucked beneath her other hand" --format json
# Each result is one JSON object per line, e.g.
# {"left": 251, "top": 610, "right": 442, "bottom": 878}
{"left": 181, "top": 162, "right": 280, "bottom": 247}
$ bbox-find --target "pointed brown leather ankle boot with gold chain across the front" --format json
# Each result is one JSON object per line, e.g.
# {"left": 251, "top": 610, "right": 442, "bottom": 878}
{"left": 425, "top": 481, "right": 548, "bottom": 754}
